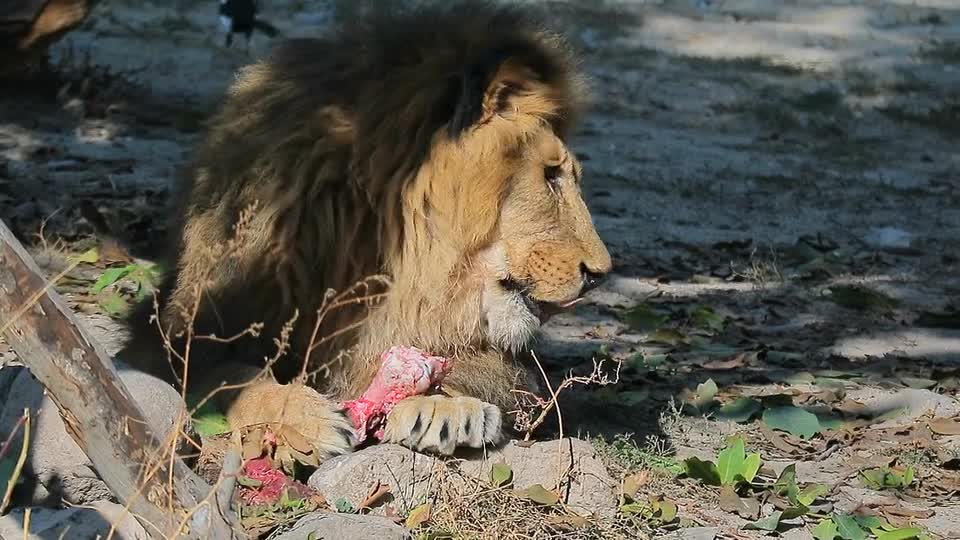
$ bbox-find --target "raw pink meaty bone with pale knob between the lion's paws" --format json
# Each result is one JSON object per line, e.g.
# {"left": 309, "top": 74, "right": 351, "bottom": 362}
{"left": 343, "top": 346, "right": 450, "bottom": 442}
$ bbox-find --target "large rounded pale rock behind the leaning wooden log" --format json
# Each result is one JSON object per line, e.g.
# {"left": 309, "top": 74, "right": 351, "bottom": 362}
{"left": 0, "top": 363, "right": 186, "bottom": 505}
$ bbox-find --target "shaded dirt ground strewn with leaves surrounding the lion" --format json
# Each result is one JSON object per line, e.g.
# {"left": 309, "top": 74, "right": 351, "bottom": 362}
{"left": 0, "top": 0, "right": 960, "bottom": 538}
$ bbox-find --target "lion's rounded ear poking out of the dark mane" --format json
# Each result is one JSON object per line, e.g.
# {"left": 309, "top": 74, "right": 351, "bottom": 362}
{"left": 450, "top": 55, "right": 540, "bottom": 137}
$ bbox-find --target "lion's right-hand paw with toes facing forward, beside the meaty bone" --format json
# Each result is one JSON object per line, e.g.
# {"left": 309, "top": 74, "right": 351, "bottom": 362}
{"left": 383, "top": 396, "right": 502, "bottom": 455}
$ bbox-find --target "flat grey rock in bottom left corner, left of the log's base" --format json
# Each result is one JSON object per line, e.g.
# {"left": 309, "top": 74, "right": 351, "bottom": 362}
{"left": 0, "top": 501, "right": 150, "bottom": 540}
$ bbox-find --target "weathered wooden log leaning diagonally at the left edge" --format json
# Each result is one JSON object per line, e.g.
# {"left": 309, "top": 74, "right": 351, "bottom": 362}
{"left": 0, "top": 220, "right": 245, "bottom": 539}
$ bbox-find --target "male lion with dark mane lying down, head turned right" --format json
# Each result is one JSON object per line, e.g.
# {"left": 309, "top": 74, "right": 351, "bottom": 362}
{"left": 127, "top": 2, "right": 611, "bottom": 456}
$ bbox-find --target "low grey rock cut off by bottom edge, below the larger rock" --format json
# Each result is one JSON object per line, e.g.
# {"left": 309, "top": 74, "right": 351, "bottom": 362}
{"left": 273, "top": 512, "right": 412, "bottom": 540}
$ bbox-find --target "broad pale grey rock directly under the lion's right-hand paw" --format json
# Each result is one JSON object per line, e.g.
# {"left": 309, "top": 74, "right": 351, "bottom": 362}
{"left": 308, "top": 439, "right": 617, "bottom": 515}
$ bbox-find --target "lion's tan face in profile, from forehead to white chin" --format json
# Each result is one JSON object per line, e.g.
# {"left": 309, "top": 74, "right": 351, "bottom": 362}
{"left": 483, "top": 129, "right": 611, "bottom": 350}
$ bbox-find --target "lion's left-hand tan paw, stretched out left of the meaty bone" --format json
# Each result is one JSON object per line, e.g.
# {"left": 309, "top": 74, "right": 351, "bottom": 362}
{"left": 227, "top": 382, "right": 357, "bottom": 459}
